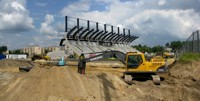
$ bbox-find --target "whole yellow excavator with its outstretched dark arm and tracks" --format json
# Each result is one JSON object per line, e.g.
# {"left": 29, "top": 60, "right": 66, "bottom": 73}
{"left": 79, "top": 50, "right": 168, "bottom": 85}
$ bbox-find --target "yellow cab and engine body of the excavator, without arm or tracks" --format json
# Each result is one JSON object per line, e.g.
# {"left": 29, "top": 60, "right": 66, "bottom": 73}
{"left": 126, "top": 52, "right": 166, "bottom": 73}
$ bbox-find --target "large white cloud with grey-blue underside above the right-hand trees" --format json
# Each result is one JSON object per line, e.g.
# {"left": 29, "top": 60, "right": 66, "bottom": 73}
{"left": 125, "top": 10, "right": 200, "bottom": 45}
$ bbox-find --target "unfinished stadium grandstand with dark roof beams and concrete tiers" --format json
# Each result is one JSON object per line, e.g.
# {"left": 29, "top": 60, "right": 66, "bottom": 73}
{"left": 60, "top": 16, "right": 138, "bottom": 55}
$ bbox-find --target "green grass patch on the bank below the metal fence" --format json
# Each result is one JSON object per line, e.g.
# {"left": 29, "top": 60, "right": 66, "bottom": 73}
{"left": 179, "top": 53, "right": 200, "bottom": 62}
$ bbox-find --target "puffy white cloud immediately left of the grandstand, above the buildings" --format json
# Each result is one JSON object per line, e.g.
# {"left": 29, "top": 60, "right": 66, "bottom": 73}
{"left": 38, "top": 14, "right": 64, "bottom": 46}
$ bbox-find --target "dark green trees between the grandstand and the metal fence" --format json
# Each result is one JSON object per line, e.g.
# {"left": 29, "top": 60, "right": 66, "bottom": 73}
{"left": 132, "top": 41, "right": 185, "bottom": 53}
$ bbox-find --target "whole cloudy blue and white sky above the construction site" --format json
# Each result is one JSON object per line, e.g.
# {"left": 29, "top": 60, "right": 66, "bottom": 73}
{"left": 0, "top": 0, "right": 200, "bottom": 49}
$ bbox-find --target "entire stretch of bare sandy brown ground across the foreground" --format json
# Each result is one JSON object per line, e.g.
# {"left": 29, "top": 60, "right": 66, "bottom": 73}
{"left": 0, "top": 60, "right": 200, "bottom": 101}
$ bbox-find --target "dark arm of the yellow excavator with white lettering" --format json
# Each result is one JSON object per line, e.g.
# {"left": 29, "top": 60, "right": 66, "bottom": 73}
{"left": 79, "top": 50, "right": 126, "bottom": 65}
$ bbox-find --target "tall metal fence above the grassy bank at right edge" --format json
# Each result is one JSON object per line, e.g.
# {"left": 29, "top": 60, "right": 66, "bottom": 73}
{"left": 181, "top": 30, "right": 200, "bottom": 53}
